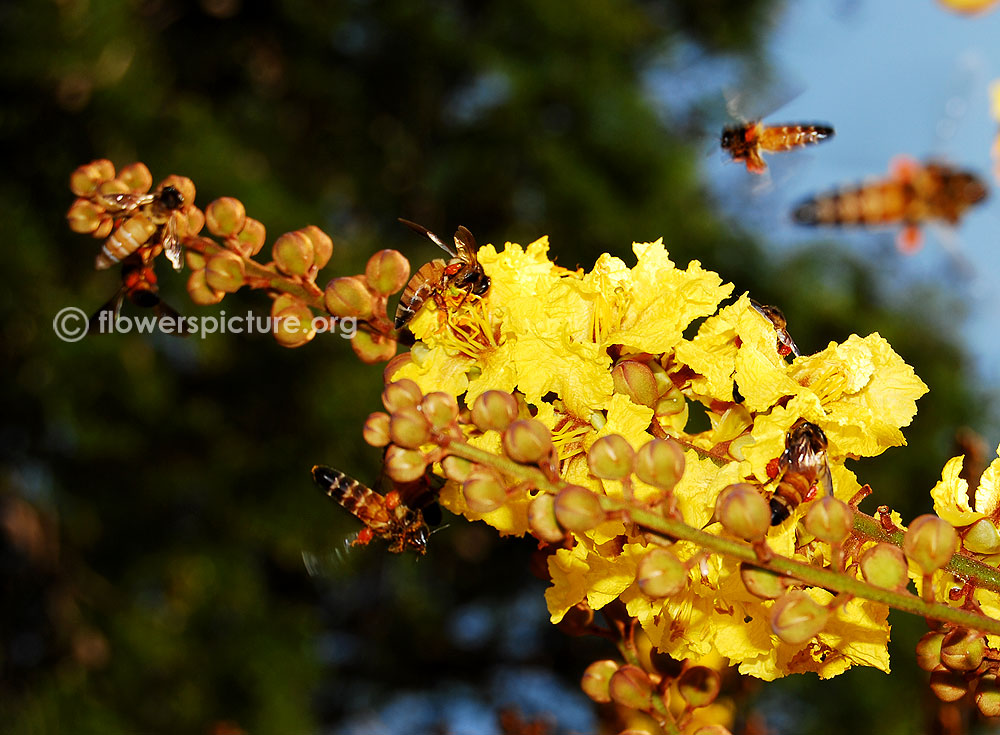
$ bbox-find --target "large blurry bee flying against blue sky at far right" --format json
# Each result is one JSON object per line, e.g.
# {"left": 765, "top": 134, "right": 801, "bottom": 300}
{"left": 792, "top": 158, "right": 987, "bottom": 251}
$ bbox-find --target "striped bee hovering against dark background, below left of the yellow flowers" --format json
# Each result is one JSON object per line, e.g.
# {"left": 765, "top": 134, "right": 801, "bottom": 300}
{"left": 312, "top": 465, "right": 431, "bottom": 556}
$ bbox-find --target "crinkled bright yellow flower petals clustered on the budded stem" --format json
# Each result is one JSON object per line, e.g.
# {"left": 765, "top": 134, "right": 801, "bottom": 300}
{"left": 392, "top": 239, "right": 927, "bottom": 679}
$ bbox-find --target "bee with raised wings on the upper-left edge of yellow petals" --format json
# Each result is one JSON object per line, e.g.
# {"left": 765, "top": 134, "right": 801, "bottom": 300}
{"left": 395, "top": 218, "right": 490, "bottom": 330}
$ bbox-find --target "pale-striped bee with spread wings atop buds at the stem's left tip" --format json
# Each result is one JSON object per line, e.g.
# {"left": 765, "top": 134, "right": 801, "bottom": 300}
{"left": 96, "top": 184, "right": 184, "bottom": 270}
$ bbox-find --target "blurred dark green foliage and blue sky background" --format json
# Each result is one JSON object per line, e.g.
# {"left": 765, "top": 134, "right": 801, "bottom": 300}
{"left": 0, "top": 0, "right": 1000, "bottom": 735}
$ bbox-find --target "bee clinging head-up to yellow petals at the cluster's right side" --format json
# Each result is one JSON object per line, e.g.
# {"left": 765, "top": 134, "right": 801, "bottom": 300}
{"left": 770, "top": 419, "right": 833, "bottom": 526}
